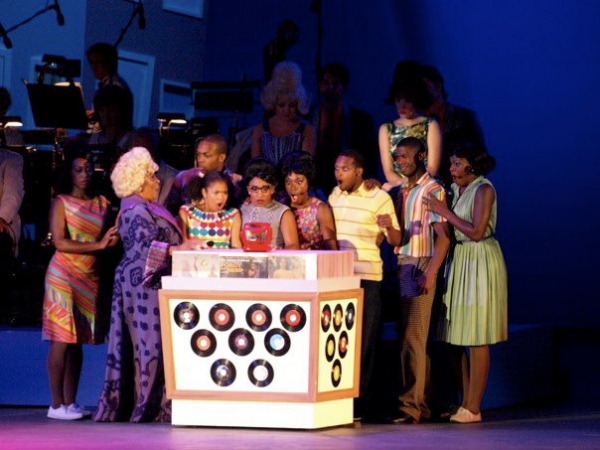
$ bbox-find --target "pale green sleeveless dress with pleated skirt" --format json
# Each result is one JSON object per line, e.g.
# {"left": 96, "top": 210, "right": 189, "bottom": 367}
{"left": 439, "top": 177, "right": 508, "bottom": 346}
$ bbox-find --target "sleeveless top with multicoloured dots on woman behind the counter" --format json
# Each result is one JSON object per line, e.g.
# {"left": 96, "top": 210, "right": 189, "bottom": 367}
{"left": 181, "top": 205, "right": 240, "bottom": 248}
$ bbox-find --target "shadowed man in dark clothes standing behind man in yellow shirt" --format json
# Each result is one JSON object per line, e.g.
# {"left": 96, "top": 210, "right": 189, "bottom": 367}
{"left": 312, "top": 63, "right": 379, "bottom": 198}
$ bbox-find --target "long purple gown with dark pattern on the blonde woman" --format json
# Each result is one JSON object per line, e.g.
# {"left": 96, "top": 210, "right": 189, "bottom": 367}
{"left": 94, "top": 195, "right": 181, "bottom": 422}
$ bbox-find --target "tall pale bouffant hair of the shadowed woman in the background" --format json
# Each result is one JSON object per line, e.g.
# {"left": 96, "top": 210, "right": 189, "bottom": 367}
{"left": 260, "top": 61, "right": 310, "bottom": 114}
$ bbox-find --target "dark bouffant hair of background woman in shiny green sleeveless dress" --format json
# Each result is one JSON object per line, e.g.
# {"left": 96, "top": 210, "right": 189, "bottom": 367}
{"left": 387, "top": 60, "right": 433, "bottom": 112}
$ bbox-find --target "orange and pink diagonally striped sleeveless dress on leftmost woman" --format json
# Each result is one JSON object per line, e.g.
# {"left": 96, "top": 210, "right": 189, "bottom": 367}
{"left": 42, "top": 195, "right": 108, "bottom": 344}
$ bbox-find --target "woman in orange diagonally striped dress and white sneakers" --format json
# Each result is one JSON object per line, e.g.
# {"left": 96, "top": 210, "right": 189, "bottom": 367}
{"left": 42, "top": 149, "right": 119, "bottom": 420}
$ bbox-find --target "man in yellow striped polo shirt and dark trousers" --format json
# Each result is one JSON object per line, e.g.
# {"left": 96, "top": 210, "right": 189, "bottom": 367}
{"left": 329, "top": 150, "right": 401, "bottom": 419}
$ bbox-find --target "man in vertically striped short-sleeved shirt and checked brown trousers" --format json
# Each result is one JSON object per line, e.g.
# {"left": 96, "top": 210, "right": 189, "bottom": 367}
{"left": 392, "top": 137, "right": 450, "bottom": 423}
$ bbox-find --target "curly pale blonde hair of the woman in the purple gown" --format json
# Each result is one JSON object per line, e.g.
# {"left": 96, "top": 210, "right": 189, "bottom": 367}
{"left": 110, "top": 147, "right": 158, "bottom": 198}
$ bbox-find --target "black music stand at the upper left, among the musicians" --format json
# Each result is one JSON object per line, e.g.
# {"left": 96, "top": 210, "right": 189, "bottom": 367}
{"left": 27, "top": 83, "right": 88, "bottom": 130}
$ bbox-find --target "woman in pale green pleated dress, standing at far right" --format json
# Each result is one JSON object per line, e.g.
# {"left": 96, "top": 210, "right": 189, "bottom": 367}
{"left": 425, "top": 144, "right": 508, "bottom": 423}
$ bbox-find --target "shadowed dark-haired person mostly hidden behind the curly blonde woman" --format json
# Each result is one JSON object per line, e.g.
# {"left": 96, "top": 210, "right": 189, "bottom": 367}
{"left": 120, "top": 127, "right": 178, "bottom": 206}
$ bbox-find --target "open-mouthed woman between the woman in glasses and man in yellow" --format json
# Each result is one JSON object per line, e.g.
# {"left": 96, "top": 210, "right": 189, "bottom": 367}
{"left": 279, "top": 152, "right": 338, "bottom": 250}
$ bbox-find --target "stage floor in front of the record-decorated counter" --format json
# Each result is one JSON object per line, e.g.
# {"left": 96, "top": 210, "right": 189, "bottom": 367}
{"left": 0, "top": 403, "right": 600, "bottom": 450}
